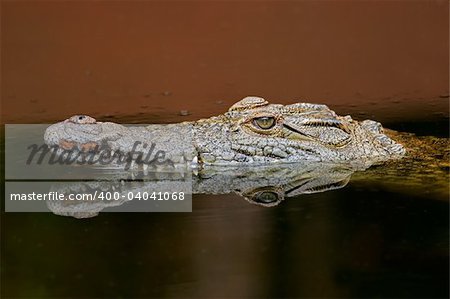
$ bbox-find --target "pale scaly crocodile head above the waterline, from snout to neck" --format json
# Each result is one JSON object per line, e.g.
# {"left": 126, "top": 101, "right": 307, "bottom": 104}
{"left": 44, "top": 96, "right": 406, "bottom": 168}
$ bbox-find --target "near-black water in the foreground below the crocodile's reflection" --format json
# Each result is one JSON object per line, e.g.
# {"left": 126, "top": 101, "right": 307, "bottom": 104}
{"left": 1, "top": 118, "right": 449, "bottom": 298}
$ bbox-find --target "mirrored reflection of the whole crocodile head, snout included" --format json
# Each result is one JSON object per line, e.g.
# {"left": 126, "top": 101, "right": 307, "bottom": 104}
{"left": 47, "top": 162, "right": 367, "bottom": 218}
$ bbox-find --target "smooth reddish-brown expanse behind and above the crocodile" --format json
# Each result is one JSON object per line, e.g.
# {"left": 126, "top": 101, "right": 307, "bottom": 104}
{"left": 1, "top": 0, "right": 449, "bottom": 123}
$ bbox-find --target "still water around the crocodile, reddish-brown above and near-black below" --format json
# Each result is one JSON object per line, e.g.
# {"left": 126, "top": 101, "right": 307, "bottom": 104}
{"left": 1, "top": 1, "right": 449, "bottom": 298}
